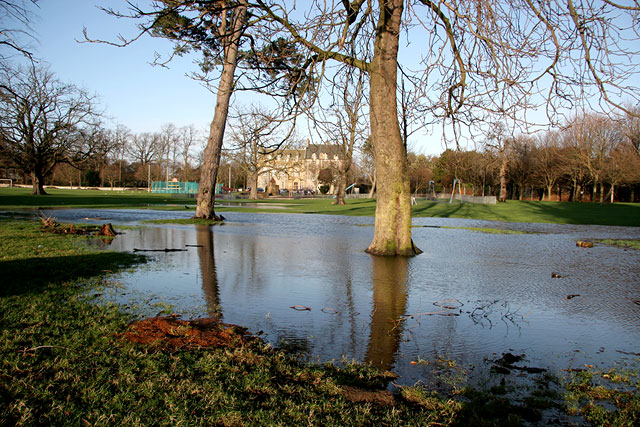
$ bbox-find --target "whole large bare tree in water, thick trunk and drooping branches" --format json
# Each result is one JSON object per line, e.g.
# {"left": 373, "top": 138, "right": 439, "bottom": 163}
{"left": 256, "top": 0, "right": 640, "bottom": 255}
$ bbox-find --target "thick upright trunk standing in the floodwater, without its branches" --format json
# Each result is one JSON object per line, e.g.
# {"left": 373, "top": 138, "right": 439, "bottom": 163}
{"left": 367, "top": 0, "right": 420, "bottom": 256}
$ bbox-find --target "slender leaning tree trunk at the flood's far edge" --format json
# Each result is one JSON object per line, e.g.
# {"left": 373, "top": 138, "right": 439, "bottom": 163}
{"left": 194, "top": 3, "right": 247, "bottom": 221}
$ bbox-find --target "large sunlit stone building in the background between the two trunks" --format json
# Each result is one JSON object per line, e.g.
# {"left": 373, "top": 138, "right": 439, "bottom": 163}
{"left": 258, "top": 141, "right": 344, "bottom": 192}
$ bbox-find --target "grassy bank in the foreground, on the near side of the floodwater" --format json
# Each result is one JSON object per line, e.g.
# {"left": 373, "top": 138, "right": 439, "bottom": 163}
{"left": 0, "top": 220, "right": 640, "bottom": 426}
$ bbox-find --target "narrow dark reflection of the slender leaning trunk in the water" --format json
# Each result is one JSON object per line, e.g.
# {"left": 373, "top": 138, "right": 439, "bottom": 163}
{"left": 196, "top": 225, "right": 222, "bottom": 317}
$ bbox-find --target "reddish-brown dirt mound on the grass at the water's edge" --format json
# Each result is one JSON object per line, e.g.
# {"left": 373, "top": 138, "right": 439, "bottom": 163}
{"left": 121, "top": 316, "right": 252, "bottom": 351}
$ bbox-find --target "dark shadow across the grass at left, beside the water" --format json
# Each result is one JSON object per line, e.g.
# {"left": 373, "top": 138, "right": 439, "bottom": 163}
{"left": 0, "top": 252, "right": 145, "bottom": 297}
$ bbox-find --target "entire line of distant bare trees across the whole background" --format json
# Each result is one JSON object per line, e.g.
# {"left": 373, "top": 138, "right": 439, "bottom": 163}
{"left": 0, "top": 66, "right": 640, "bottom": 202}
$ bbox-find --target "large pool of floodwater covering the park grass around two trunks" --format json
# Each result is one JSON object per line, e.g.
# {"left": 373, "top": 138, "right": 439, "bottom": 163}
{"left": 42, "top": 210, "right": 640, "bottom": 384}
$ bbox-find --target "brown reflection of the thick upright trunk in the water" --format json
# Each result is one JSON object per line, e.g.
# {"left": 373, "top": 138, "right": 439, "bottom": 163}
{"left": 365, "top": 257, "right": 409, "bottom": 370}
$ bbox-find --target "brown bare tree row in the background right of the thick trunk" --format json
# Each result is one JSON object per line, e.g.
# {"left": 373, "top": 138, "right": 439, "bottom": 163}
{"left": 409, "top": 113, "right": 640, "bottom": 202}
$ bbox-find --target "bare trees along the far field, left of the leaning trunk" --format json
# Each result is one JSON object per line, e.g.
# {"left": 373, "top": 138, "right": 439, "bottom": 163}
{"left": 0, "top": 64, "right": 203, "bottom": 194}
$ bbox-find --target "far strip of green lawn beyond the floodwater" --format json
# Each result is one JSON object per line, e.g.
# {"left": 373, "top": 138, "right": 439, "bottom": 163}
{"left": 0, "top": 188, "right": 640, "bottom": 227}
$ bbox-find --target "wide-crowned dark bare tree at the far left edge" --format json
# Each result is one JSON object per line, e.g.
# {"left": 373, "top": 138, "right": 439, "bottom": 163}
{"left": 0, "top": 67, "right": 97, "bottom": 194}
